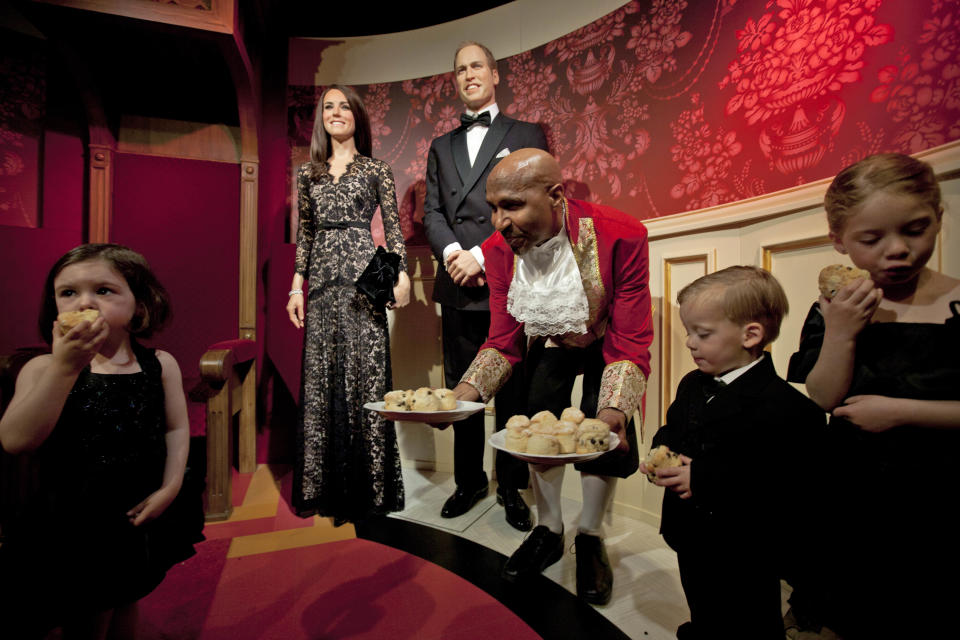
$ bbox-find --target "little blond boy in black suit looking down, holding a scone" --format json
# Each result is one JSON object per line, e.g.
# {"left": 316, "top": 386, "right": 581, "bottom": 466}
{"left": 640, "top": 266, "right": 825, "bottom": 640}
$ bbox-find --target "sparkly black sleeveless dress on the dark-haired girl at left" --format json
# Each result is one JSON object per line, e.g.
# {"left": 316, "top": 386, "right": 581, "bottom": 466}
{"left": 0, "top": 344, "right": 203, "bottom": 637}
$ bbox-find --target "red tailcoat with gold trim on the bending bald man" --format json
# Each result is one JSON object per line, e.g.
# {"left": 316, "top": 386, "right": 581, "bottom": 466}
{"left": 461, "top": 200, "right": 653, "bottom": 416}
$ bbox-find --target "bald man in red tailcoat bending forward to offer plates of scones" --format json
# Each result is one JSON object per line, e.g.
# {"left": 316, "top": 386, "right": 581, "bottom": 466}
{"left": 454, "top": 149, "right": 653, "bottom": 604}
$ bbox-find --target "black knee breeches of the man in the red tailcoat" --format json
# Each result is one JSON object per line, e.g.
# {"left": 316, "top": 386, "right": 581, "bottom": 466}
{"left": 520, "top": 339, "right": 640, "bottom": 478}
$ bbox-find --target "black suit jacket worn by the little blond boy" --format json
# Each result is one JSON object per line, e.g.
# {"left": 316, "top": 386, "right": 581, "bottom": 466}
{"left": 653, "top": 354, "right": 827, "bottom": 562}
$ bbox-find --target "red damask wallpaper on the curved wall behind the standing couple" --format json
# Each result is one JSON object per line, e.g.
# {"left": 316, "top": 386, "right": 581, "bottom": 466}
{"left": 288, "top": 0, "right": 960, "bottom": 243}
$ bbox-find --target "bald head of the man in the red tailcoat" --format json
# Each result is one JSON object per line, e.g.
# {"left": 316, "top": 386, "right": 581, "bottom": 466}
{"left": 487, "top": 149, "right": 564, "bottom": 255}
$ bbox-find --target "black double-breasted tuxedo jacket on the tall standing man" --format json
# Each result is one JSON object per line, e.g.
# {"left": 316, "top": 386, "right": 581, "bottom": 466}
{"left": 423, "top": 112, "right": 548, "bottom": 311}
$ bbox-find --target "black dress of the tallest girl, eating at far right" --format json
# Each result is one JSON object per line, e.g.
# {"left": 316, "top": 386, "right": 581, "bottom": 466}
{"left": 787, "top": 301, "right": 960, "bottom": 638}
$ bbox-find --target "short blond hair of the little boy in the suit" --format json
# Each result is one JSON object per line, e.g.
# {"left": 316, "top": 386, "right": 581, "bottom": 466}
{"left": 677, "top": 266, "right": 790, "bottom": 348}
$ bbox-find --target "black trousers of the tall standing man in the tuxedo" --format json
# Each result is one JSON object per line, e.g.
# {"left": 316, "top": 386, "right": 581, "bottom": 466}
{"left": 442, "top": 305, "right": 530, "bottom": 489}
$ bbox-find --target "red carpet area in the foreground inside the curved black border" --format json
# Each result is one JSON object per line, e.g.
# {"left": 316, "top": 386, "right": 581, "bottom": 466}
{"left": 141, "top": 539, "right": 540, "bottom": 640}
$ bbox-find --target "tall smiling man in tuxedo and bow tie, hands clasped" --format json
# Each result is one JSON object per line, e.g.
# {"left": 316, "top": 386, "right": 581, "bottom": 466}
{"left": 423, "top": 42, "right": 547, "bottom": 531}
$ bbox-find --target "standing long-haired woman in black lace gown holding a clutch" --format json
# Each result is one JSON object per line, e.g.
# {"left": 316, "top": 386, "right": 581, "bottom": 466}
{"left": 287, "top": 85, "right": 410, "bottom": 524}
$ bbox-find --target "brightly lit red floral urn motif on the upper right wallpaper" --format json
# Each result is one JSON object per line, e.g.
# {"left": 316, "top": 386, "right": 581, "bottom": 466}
{"left": 719, "top": 0, "right": 893, "bottom": 174}
